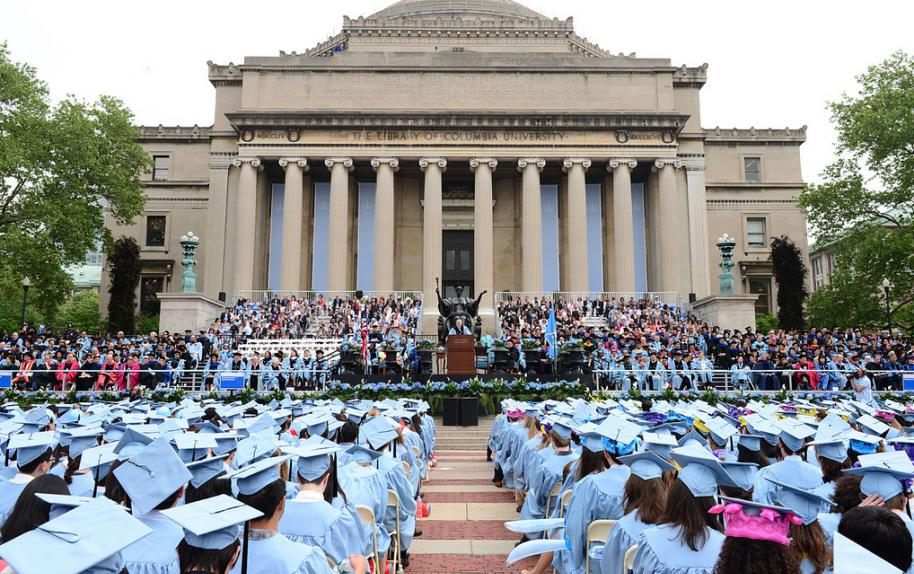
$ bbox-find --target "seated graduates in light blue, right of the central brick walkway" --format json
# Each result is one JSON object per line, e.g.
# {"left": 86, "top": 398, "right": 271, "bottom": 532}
{"left": 489, "top": 395, "right": 914, "bottom": 574}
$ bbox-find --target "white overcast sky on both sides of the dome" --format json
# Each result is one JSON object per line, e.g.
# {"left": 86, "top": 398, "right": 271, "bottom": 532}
{"left": 0, "top": 0, "right": 914, "bottom": 181}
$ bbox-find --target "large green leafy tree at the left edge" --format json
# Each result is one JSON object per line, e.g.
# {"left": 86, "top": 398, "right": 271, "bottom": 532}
{"left": 0, "top": 44, "right": 150, "bottom": 324}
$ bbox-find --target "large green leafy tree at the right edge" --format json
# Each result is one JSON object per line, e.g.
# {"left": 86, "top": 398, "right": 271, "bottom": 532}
{"left": 800, "top": 52, "right": 914, "bottom": 327}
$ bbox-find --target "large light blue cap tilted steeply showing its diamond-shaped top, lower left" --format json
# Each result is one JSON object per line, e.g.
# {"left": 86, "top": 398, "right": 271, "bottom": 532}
{"left": 114, "top": 437, "right": 192, "bottom": 516}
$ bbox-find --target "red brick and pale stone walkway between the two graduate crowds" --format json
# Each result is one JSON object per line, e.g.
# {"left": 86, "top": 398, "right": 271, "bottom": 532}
{"left": 406, "top": 420, "right": 535, "bottom": 574}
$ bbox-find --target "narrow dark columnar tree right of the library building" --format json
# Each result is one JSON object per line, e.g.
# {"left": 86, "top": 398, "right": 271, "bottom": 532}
{"left": 771, "top": 235, "right": 809, "bottom": 331}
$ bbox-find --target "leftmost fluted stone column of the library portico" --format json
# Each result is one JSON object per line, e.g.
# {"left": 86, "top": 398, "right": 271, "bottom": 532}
{"left": 232, "top": 157, "right": 260, "bottom": 299}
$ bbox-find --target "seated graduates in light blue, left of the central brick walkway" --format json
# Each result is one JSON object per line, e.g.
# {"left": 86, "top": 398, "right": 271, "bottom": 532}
{"left": 0, "top": 398, "right": 435, "bottom": 574}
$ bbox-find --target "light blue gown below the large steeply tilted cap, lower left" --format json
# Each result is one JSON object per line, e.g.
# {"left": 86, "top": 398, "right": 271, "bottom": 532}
{"left": 122, "top": 510, "right": 184, "bottom": 574}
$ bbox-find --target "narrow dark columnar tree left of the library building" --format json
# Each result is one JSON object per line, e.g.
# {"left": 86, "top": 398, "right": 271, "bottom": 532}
{"left": 108, "top": 237, "right": 142, "bottom": 335}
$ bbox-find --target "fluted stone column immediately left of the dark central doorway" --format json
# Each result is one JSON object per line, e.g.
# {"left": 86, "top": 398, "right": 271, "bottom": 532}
{"left": 419, "top": 157, "right": 447, "bottom": 335}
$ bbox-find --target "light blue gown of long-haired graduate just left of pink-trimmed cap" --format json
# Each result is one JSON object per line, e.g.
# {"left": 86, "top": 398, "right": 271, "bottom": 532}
{"left": 632, "top": 524, "right": 726, "bottom": 574}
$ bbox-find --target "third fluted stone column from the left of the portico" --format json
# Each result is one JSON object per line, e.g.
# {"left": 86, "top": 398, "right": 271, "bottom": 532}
{"left": 324, "top": 157, "right": 354, "bottom": 291}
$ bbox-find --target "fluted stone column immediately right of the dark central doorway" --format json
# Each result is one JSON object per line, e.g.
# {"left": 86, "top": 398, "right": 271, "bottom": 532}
{"left": 470, "top": 157, "right": 498, "bottom": 334}
